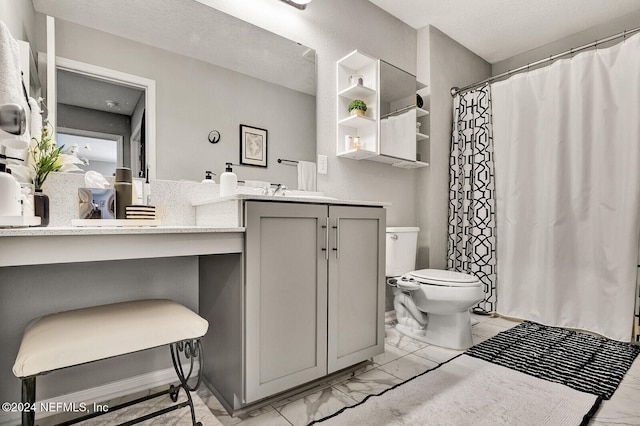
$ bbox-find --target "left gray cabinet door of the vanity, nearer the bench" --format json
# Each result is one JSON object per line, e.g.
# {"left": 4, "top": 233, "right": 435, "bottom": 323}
{"left": 244, "top": 202, "right": 327, "bottom": 403}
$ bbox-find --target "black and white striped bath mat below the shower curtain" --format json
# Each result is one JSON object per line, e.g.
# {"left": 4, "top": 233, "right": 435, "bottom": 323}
{"left": 466, "top": 321, "right": 640, "bottom": 399}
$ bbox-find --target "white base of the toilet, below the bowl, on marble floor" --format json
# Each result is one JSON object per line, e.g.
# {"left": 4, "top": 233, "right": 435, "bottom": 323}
{"left": 395, "top": 311, "right": 473, "bottom": 350}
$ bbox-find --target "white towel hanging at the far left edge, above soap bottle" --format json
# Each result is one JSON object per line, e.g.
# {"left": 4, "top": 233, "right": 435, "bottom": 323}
{"left": 0, "top": 21, "right": 30, "bottom": 141}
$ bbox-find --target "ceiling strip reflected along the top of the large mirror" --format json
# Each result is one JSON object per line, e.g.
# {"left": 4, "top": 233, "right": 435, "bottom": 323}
{"left": 32, "top": 0, "right": 315, "bottom": 94}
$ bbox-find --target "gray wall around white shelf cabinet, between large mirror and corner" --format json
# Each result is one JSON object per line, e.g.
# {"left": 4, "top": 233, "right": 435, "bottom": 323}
{"left": 206, "top": 0, "right": 418, "bottom": 226}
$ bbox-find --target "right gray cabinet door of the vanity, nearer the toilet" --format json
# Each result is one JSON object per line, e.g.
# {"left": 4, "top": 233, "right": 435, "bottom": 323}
{"left": 327, "top": 206, "right": 386, "bottom": 373}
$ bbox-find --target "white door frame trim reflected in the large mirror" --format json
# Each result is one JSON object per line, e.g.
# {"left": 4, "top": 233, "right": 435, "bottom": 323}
{"left": 53, "top": 56, "right": 156, "bottom": 179}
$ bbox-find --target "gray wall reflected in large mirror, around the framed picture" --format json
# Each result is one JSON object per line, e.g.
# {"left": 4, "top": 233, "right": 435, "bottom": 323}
{"left": 56, "top": 19, "right": 315, "bottom": 188}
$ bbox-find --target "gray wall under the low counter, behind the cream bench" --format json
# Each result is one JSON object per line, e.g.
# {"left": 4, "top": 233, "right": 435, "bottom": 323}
{"left": 0, "top": 256, "right": 198, "bottom": 406}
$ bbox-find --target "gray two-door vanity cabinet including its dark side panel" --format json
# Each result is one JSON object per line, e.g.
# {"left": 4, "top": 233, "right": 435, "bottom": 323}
{"left": 199, "top": 196, "right": 385, "bottom": 411}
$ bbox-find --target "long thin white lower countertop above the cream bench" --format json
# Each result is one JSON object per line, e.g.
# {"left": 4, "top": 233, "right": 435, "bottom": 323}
{"left": 0, "top": 226, "right": 245, "bottom": 237}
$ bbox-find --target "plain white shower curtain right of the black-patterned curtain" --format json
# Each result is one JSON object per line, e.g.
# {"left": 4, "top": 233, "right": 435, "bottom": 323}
{"left": 492, "top": 34, "right": 640, "bottom": 342}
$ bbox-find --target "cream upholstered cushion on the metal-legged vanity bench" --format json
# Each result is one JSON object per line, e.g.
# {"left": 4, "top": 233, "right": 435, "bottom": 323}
{"left": 13, "top": 299, "right": 209, "bottom": 377}
